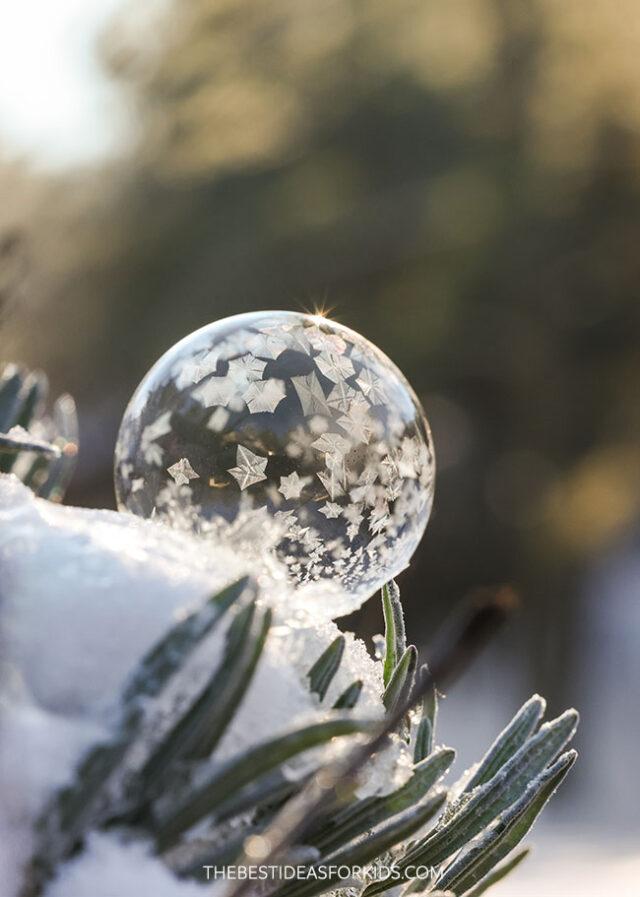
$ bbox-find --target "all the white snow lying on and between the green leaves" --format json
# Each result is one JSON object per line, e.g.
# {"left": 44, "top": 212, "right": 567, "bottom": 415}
{"left": 0, "top": 475, "right": 411, "bottom": 897}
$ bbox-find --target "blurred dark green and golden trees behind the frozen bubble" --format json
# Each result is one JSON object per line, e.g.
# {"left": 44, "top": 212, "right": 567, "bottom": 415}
{"left": 1, "top": 0, "right": 640, "bottom": 701}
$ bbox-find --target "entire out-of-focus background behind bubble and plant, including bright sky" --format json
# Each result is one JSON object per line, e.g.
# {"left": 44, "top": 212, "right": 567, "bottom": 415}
{"left": 0, "top": 0, "right": 640, "bottom": 897}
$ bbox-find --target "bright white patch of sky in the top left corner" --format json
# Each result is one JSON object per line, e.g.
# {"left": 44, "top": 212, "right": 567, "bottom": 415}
{"left": 0, "top": 0, "right": 129, "bottom": 170}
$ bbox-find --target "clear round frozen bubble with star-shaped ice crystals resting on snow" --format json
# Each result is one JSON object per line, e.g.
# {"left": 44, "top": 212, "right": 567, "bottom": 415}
{"left": 115, "top": 312, "right": 434, "bottom": 597}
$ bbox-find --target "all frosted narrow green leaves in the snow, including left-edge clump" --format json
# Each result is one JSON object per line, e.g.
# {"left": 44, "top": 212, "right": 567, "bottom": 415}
{"left": 8, "top": 384, "right": 578, "bottom": 897}
